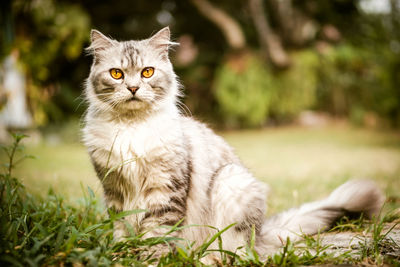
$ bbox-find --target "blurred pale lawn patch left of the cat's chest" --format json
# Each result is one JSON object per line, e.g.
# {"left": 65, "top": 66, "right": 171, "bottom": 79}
{"left": 9, "top": 142, "right": 101, "bottom": 201}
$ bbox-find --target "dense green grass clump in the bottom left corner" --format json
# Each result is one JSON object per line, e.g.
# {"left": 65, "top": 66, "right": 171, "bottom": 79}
{"left": 0, "top": 135, "right": 111, "bottom": 266}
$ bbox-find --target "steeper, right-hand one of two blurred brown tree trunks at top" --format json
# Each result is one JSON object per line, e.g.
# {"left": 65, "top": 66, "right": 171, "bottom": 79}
{"left": 249, "top": 0, "right": 290, "bottom": 68}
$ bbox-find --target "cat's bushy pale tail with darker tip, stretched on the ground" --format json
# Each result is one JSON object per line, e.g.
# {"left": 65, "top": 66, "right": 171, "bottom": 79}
{"left": 256, "top": 180, "right": 385, "bottom": 254}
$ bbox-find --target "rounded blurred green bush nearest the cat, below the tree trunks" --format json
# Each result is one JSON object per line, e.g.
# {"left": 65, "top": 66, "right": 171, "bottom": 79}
{"left": 214, "top": 56, "right": 273, "bottom": 126}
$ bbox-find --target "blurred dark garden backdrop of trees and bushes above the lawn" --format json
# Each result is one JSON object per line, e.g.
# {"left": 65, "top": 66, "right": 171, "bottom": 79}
{"left": 0, "top": 0, "right": 400, "bottom": 131}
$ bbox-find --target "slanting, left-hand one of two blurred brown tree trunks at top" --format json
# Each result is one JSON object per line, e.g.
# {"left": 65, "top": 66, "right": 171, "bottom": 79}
{"left": 191, "top": 0, "right": 246, "bottom": 50}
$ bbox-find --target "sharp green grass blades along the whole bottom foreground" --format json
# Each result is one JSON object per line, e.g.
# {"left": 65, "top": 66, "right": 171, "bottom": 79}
{"left": 0, "top": 134, "right": 397, "bottom": 266}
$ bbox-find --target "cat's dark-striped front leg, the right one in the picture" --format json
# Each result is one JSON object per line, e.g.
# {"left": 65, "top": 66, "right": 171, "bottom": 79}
{"left": 140, "top": 157, "right": 191, "bottom": 255}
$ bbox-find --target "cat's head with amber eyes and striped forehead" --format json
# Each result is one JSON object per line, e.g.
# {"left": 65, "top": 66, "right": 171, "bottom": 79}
{"left": 86, "top": 27, "right": 178, "bottom": 118}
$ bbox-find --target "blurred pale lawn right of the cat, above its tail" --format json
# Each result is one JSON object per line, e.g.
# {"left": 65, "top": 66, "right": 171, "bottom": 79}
{"left": 223, "top": 126, "right": 400, "bottom": 213}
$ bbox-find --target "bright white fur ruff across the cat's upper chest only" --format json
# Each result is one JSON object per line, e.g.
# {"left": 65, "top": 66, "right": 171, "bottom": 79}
{"left": 84, "top": 112, "right": 181, "bottom": 177}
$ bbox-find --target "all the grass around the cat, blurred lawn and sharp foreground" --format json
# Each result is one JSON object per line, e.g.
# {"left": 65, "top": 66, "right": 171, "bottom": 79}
{"left": 0, "top": 124, "right": 400, "bottom": 266}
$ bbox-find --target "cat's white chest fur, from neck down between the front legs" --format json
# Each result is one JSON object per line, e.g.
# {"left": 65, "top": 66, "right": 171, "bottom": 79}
{"left": 84, "top": 111, "right": 186, "bottom": 225}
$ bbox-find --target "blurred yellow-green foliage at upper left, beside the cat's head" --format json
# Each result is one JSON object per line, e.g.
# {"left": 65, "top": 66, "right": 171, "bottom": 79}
{"left": 9, "top": 0, "right": 90, "bottom": 126}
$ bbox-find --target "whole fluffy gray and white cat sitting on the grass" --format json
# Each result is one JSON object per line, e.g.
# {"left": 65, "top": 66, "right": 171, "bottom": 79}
{"left": 83, "top": 28, "right": 384, "bottom": 262}
